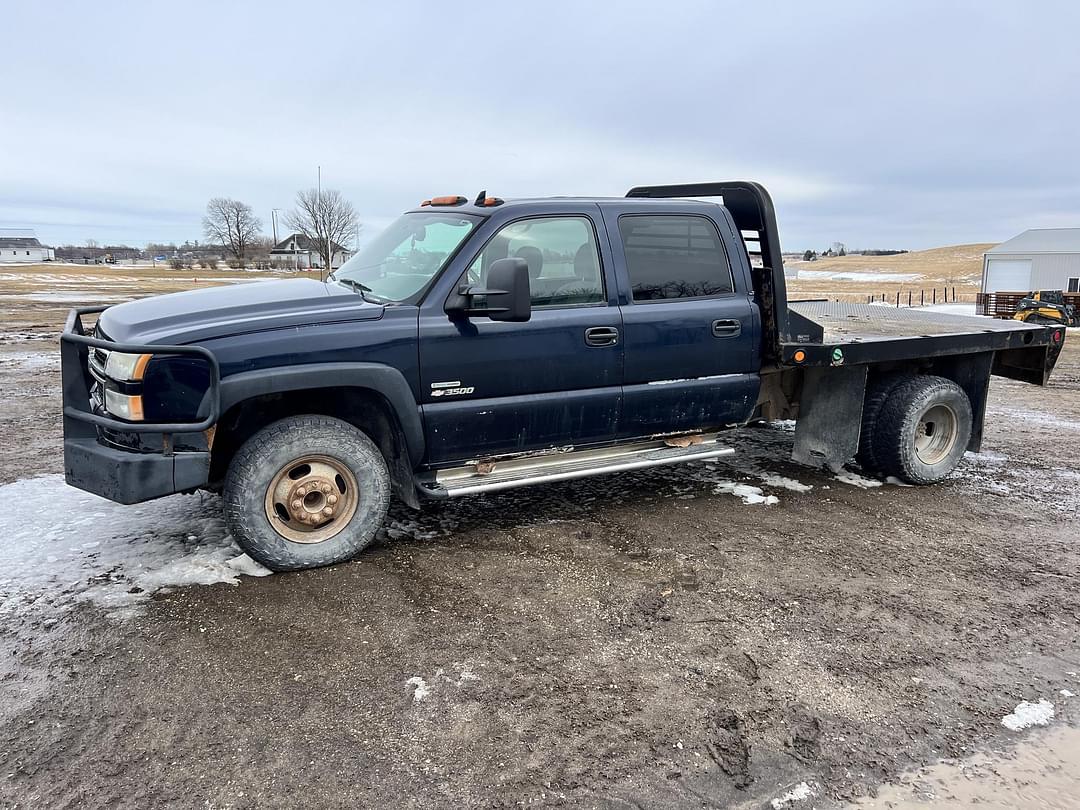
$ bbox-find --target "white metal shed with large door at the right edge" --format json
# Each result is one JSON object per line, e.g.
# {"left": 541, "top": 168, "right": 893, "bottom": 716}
{"left": 983, "top": 228, "right": 1080, "bottom": 293}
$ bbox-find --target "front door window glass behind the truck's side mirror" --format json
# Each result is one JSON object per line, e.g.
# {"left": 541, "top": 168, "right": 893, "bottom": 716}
{"left": 468, "top": 216, "right": 606, "bottom": 307}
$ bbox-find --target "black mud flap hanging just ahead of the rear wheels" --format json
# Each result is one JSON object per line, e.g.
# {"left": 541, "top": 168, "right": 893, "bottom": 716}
{"left": 792, "top": 365, "right": 866, "bottom": 472}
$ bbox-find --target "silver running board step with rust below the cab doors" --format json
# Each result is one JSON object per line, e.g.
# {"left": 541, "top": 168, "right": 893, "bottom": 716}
{"left": 421, "top": 433, "right": 734, "bottom": 498}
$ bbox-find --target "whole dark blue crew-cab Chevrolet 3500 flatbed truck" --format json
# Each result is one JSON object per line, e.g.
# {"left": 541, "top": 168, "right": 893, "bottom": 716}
{"left": 62, "top": 183, "right": 1065, "bottom": 570}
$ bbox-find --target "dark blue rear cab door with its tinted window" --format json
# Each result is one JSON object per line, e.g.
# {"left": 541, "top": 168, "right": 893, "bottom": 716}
{"left": 604, "top": 203, "right": 760, "bottom": 437}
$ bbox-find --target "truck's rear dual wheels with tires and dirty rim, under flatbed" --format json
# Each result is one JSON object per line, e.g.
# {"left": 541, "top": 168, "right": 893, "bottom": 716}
{"left": 874, "top": 375, "right": 972, "bottom": 485}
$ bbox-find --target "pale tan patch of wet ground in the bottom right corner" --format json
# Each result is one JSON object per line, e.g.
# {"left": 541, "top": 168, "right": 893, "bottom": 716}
{"left": 853, "top": 726, "right": 1080, "bottom": 810}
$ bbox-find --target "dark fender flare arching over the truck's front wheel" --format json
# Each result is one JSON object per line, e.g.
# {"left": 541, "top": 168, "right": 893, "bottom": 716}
{"left": 220, "top": 363, "right": 426, "bottom": 468}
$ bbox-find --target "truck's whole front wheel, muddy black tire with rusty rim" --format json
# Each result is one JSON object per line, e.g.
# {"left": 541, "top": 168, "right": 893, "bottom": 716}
{"left": 224, "top": 415, "right": 390, "bottom": 571}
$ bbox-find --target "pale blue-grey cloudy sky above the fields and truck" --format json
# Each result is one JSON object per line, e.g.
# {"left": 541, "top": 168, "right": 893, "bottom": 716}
{"left": 0, "top": 0, "right": 1080, "bottom": 251}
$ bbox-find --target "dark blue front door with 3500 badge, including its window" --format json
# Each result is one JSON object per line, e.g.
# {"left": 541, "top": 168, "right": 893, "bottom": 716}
{"left": 420, "top": 205, "right": 623, "bottom": 465}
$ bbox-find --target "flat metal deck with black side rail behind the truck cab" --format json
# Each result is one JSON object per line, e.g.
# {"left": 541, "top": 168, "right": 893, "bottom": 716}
{"left": 782, "top": 301, "right": 1062, "bottom": 366}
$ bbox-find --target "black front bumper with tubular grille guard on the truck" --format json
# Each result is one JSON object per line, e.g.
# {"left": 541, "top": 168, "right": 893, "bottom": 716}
{"left": 60, "top": 307, "right": 220, "bottom": 503}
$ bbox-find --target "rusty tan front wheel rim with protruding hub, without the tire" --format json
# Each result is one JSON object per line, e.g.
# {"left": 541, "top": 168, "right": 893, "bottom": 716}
{"left": 266, "top": 456, "right": 360, "bottom": 543}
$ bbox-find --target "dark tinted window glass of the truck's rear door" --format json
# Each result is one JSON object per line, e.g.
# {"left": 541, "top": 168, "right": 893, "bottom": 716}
{"left": 619, "top": 214, "right": 734, "bottom": 303}
